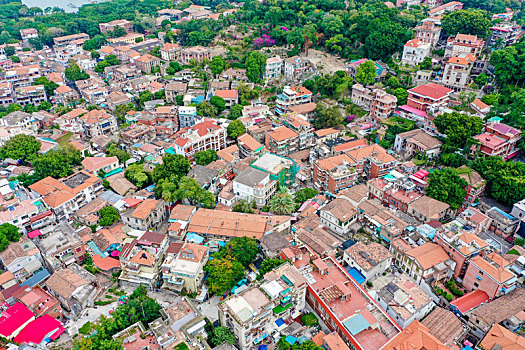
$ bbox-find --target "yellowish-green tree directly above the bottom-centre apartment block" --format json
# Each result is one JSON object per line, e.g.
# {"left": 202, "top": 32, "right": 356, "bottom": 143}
{"left": 204, "top": 259, "right": 244, "bottom": 294}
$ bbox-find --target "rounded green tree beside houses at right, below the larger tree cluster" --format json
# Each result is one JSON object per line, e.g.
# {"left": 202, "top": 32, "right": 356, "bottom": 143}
{"left": 425, "top": 168, "right": 468, "bottom": 210}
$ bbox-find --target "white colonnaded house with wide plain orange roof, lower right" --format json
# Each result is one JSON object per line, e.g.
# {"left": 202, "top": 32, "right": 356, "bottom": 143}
{"left": 390, "top": 238, "right": 456, "bottom": 285}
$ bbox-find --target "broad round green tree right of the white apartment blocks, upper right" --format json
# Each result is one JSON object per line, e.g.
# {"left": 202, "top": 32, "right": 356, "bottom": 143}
{"left": 434, "top": 112, "right": 483, "bottom": 148}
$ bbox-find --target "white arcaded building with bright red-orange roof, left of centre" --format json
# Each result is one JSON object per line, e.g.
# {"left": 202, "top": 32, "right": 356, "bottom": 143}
{"left": 172, "top": 120, "right": 226, "bottom": 161}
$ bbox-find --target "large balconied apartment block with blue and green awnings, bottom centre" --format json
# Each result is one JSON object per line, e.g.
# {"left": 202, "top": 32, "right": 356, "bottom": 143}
{"left": 218, "top": 263, "right": 307, "bottom": 349}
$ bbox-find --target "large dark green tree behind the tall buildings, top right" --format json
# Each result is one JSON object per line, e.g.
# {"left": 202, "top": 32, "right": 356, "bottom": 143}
{"left": 441, "top": 9, "right": 491, "bottom": 38}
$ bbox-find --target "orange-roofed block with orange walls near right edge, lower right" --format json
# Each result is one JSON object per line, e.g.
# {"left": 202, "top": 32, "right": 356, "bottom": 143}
{"left": 463, "top": 252, "right": 518, "bottom": 299}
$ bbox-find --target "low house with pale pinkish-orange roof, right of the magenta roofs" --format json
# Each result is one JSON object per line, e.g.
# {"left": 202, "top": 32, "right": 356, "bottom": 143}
{"left": 46, "top": 264, "right": 111, "bottom": 316}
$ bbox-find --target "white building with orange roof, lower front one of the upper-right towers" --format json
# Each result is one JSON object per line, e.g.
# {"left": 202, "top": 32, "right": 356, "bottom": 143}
{"left": 441, "top": 54, "right": 476, "bottom": 91}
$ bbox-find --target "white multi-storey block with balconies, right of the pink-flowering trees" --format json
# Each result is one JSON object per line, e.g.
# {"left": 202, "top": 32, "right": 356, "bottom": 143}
{"left": 352, "top": 84, "right": 397, "bottom": 121}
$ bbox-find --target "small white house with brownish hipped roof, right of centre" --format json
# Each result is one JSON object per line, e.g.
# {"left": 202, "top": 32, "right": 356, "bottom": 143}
{"left": 319, "top": 198, "right": 357, "bottom": 236}
